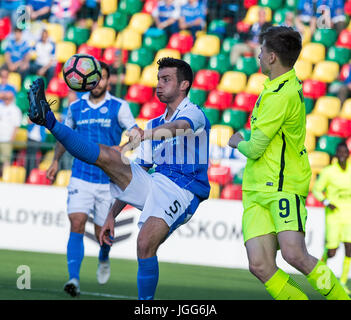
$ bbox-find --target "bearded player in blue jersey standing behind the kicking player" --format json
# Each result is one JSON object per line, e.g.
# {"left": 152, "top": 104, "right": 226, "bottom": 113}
{"left": 47, "top": 62, "right": 136, "bottom": 296}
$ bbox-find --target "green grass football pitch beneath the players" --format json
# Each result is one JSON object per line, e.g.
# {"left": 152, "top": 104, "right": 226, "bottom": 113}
{"left": 0, "top": 250, "right": 320, "bottom": 300}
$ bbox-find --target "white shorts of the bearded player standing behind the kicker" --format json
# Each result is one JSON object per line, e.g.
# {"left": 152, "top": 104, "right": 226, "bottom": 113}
{"left": 67, "top": 177, "right": 113, "bottom": 226}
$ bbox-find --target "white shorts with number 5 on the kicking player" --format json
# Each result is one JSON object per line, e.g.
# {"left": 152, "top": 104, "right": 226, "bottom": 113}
{"left": 110, "top": 162, "right": 200, "bottom": 234}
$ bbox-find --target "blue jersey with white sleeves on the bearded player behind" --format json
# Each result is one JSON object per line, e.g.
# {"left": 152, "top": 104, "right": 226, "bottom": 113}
{"left": 65, "top": 92, "right": 136, "bottom": 184}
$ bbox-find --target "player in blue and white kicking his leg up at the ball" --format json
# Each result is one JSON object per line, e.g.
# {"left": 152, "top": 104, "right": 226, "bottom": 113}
{"left": 28, "top": 57, "right": 210, "bottom": 300}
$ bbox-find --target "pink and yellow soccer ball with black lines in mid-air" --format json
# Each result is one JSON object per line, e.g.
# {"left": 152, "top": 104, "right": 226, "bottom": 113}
{"left": 62, "top": 53, "right": 101, "bottom": 91}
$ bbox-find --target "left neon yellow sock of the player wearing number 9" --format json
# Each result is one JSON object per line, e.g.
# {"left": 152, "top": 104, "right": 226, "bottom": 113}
{"left": 264, "top": 269, "right": 308, "bottom": 300}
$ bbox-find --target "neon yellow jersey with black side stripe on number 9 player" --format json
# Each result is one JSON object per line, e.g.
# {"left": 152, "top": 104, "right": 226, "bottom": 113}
{"left": 243, "top": 69, "right": 311, "bottom": 196}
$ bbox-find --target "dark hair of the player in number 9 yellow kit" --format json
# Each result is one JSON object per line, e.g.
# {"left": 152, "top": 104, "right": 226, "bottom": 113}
{"left": 260, "top": 26, "right": 302, "bottom": 68}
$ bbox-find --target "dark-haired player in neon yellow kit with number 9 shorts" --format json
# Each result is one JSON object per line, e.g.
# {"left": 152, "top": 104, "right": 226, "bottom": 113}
{"left": 229, "top": 27, "right": 350, "bottom": 300}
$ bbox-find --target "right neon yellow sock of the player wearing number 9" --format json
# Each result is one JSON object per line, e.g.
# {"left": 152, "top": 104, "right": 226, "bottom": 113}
{"left": 307, "top": 260, "right": 350, "bottom": 300}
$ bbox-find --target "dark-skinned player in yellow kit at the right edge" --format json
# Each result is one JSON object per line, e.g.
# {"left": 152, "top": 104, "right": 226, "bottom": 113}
{"left": 312, "top": 142, "right": 351, "bottom": 293}
